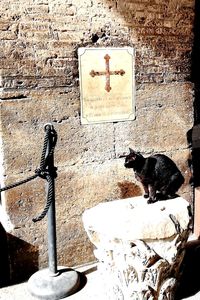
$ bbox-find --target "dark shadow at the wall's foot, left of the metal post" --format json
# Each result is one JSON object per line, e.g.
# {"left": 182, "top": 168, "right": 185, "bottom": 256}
{"left": 0, "top": 224, "right": 39, "bottom": 288}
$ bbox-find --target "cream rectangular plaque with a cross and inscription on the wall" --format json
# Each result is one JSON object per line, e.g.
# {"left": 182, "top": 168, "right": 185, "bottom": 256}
{"left": 78, "top": 47, "right": 135, "bottom": 124}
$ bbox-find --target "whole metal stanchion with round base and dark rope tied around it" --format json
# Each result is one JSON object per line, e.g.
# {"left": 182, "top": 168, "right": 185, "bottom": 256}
{"left": 0, "top": 124, "right": 80, "bottom": 300}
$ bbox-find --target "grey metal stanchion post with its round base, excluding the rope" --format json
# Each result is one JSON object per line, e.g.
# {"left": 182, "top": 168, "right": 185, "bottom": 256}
{"left": 28, "top": 124, "right": 80, "bottom": 300}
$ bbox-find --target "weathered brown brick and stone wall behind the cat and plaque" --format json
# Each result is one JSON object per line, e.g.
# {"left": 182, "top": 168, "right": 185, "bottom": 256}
{"left": 0, "top": 0, "right": 195, "bottom": 282}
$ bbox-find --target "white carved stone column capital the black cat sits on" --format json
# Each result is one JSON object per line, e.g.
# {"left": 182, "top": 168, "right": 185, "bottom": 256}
{"left": 83, "top": 197, "right": 191, "bottom": 300}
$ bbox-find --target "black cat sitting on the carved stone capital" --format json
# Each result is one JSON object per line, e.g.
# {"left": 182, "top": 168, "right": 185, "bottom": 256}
{"left": 124, "top": 148, "right": 184, "bottom": 203}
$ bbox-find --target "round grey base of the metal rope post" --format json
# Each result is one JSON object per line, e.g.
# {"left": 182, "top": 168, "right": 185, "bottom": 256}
{"left": 28, "top": 267, "right": 80, "bottom": 300}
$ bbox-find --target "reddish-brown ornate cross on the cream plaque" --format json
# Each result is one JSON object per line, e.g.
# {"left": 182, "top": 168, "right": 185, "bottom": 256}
{"left": 90, "top": 54, "right": 125, "bottom": 92}
